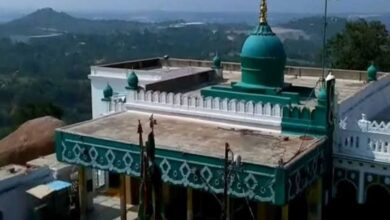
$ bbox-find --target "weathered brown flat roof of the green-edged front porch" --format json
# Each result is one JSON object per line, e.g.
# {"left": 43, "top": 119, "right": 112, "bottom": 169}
{"left": 58, "top": 111, "right": 324, "bottom": 167}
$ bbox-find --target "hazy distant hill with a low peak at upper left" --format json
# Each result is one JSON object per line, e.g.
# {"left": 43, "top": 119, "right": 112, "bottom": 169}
{"left": 0, "top": 8, "right": 150, "bottom": 37}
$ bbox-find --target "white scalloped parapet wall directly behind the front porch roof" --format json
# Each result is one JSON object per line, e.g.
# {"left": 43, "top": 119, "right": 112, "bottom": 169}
{"left": 126, "top": 90, "right": 283, "bottom": 130}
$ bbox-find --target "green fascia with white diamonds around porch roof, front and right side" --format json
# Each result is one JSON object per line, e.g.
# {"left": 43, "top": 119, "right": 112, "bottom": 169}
{"left": 56, "top": 131, "right": 326, "bottom": 205}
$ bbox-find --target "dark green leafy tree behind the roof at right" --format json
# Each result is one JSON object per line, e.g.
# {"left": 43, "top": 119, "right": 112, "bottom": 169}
{"left": 328, "top": 19, "right": 390, "bottom": 71}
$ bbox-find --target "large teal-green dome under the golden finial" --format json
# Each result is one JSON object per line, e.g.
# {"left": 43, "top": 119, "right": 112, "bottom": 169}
{"left": 239, "top": 23, "right": 286, "bottom": 88}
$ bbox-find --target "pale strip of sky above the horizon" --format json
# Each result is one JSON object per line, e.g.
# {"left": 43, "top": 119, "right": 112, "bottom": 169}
{"left": 0, "top": 0, "right": 390, "bottom": 13}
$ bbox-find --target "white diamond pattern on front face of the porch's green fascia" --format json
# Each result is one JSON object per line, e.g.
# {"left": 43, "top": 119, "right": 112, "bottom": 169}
{"left": 61, "top": 139, "right": 275, "bottom": 202}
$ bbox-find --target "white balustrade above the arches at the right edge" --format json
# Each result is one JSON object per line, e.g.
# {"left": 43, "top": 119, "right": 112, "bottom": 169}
{"left": 334, "top": 115, "right": 390, "bottom": 163}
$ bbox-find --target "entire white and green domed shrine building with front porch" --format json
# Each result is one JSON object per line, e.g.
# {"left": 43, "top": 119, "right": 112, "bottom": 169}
{"left": 56, "top": 0, "right": 390, "bottom": 220}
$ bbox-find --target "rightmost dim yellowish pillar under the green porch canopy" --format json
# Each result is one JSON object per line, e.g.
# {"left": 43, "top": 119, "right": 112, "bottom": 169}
{"left": 306, "top": 178, "right": 322, "bottom": 220}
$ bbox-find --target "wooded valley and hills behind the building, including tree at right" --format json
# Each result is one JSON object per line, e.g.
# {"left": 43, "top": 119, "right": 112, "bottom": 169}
{"left": 0, "top": 9, "right": 390, "bottom": 138}
